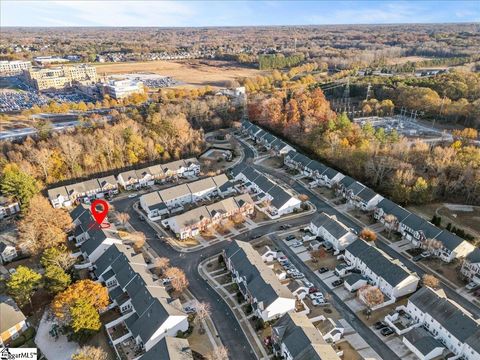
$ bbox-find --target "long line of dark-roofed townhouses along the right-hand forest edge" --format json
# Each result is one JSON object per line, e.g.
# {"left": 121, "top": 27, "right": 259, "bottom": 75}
{"left": 242, "top": 121, "right": 480, "bottom": 282}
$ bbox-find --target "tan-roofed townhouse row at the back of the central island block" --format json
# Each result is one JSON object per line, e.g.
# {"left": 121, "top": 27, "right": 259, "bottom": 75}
{"left": 140, "top": 174, "right": 234, "bottom": 219}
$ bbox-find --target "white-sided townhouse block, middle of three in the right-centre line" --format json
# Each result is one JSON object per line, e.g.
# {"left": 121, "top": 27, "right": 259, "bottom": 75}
{"left": 345, "top": 239, "right": 420, "bottom": 299}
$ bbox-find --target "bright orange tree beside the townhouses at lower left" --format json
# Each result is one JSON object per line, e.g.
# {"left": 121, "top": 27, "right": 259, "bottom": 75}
{"left": 52, "top": 279, "right": 109, "bottom": 322}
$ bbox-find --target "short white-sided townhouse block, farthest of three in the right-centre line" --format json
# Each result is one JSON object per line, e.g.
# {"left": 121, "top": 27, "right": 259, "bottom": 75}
{"left": 309, "top": 212, "right": 357, "bottom": 251}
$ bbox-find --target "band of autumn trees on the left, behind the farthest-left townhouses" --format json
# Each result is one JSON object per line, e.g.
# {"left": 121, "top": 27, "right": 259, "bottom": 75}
{"left": 0, "top": 96, "right": 241, "bottom": 208}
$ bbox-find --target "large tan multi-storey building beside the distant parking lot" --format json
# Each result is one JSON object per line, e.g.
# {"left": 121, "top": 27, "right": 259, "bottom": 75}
{"left": 24, "top": 64, "right": 98, "bottom": 90}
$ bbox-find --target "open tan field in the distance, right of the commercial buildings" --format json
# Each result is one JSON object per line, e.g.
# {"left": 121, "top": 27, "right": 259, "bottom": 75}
{"left": 95, "top": 60, "right": 264, "bottom": 87}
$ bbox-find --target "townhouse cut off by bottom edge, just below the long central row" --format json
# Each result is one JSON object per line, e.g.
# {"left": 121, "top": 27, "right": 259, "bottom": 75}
{"left": 272, "top": 313, "right": 340, "bottom": 360}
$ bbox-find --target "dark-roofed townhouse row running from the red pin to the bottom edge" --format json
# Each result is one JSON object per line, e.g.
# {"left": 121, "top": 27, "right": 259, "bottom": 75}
{"left": 70, "top": 204, "right": 193, "bottom": 360}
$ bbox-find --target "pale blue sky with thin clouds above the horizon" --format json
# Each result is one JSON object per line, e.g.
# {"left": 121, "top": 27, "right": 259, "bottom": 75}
{"left": 0, "top": 0, "right": 480, "bottom": 27}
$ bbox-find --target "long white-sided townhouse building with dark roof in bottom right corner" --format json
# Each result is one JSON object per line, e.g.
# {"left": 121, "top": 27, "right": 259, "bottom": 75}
{"left": 404, "top": 287, "right": 480, "bottom": 360}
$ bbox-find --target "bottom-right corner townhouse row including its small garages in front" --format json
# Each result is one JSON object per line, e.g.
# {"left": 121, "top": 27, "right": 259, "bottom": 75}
{"left": 385, "top": 287, "right": 480, "bottom": 360}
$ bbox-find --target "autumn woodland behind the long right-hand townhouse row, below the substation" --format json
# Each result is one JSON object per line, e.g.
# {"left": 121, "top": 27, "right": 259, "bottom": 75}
{"left": 248, "top": 89, "right": 480, "bottom": 204}
